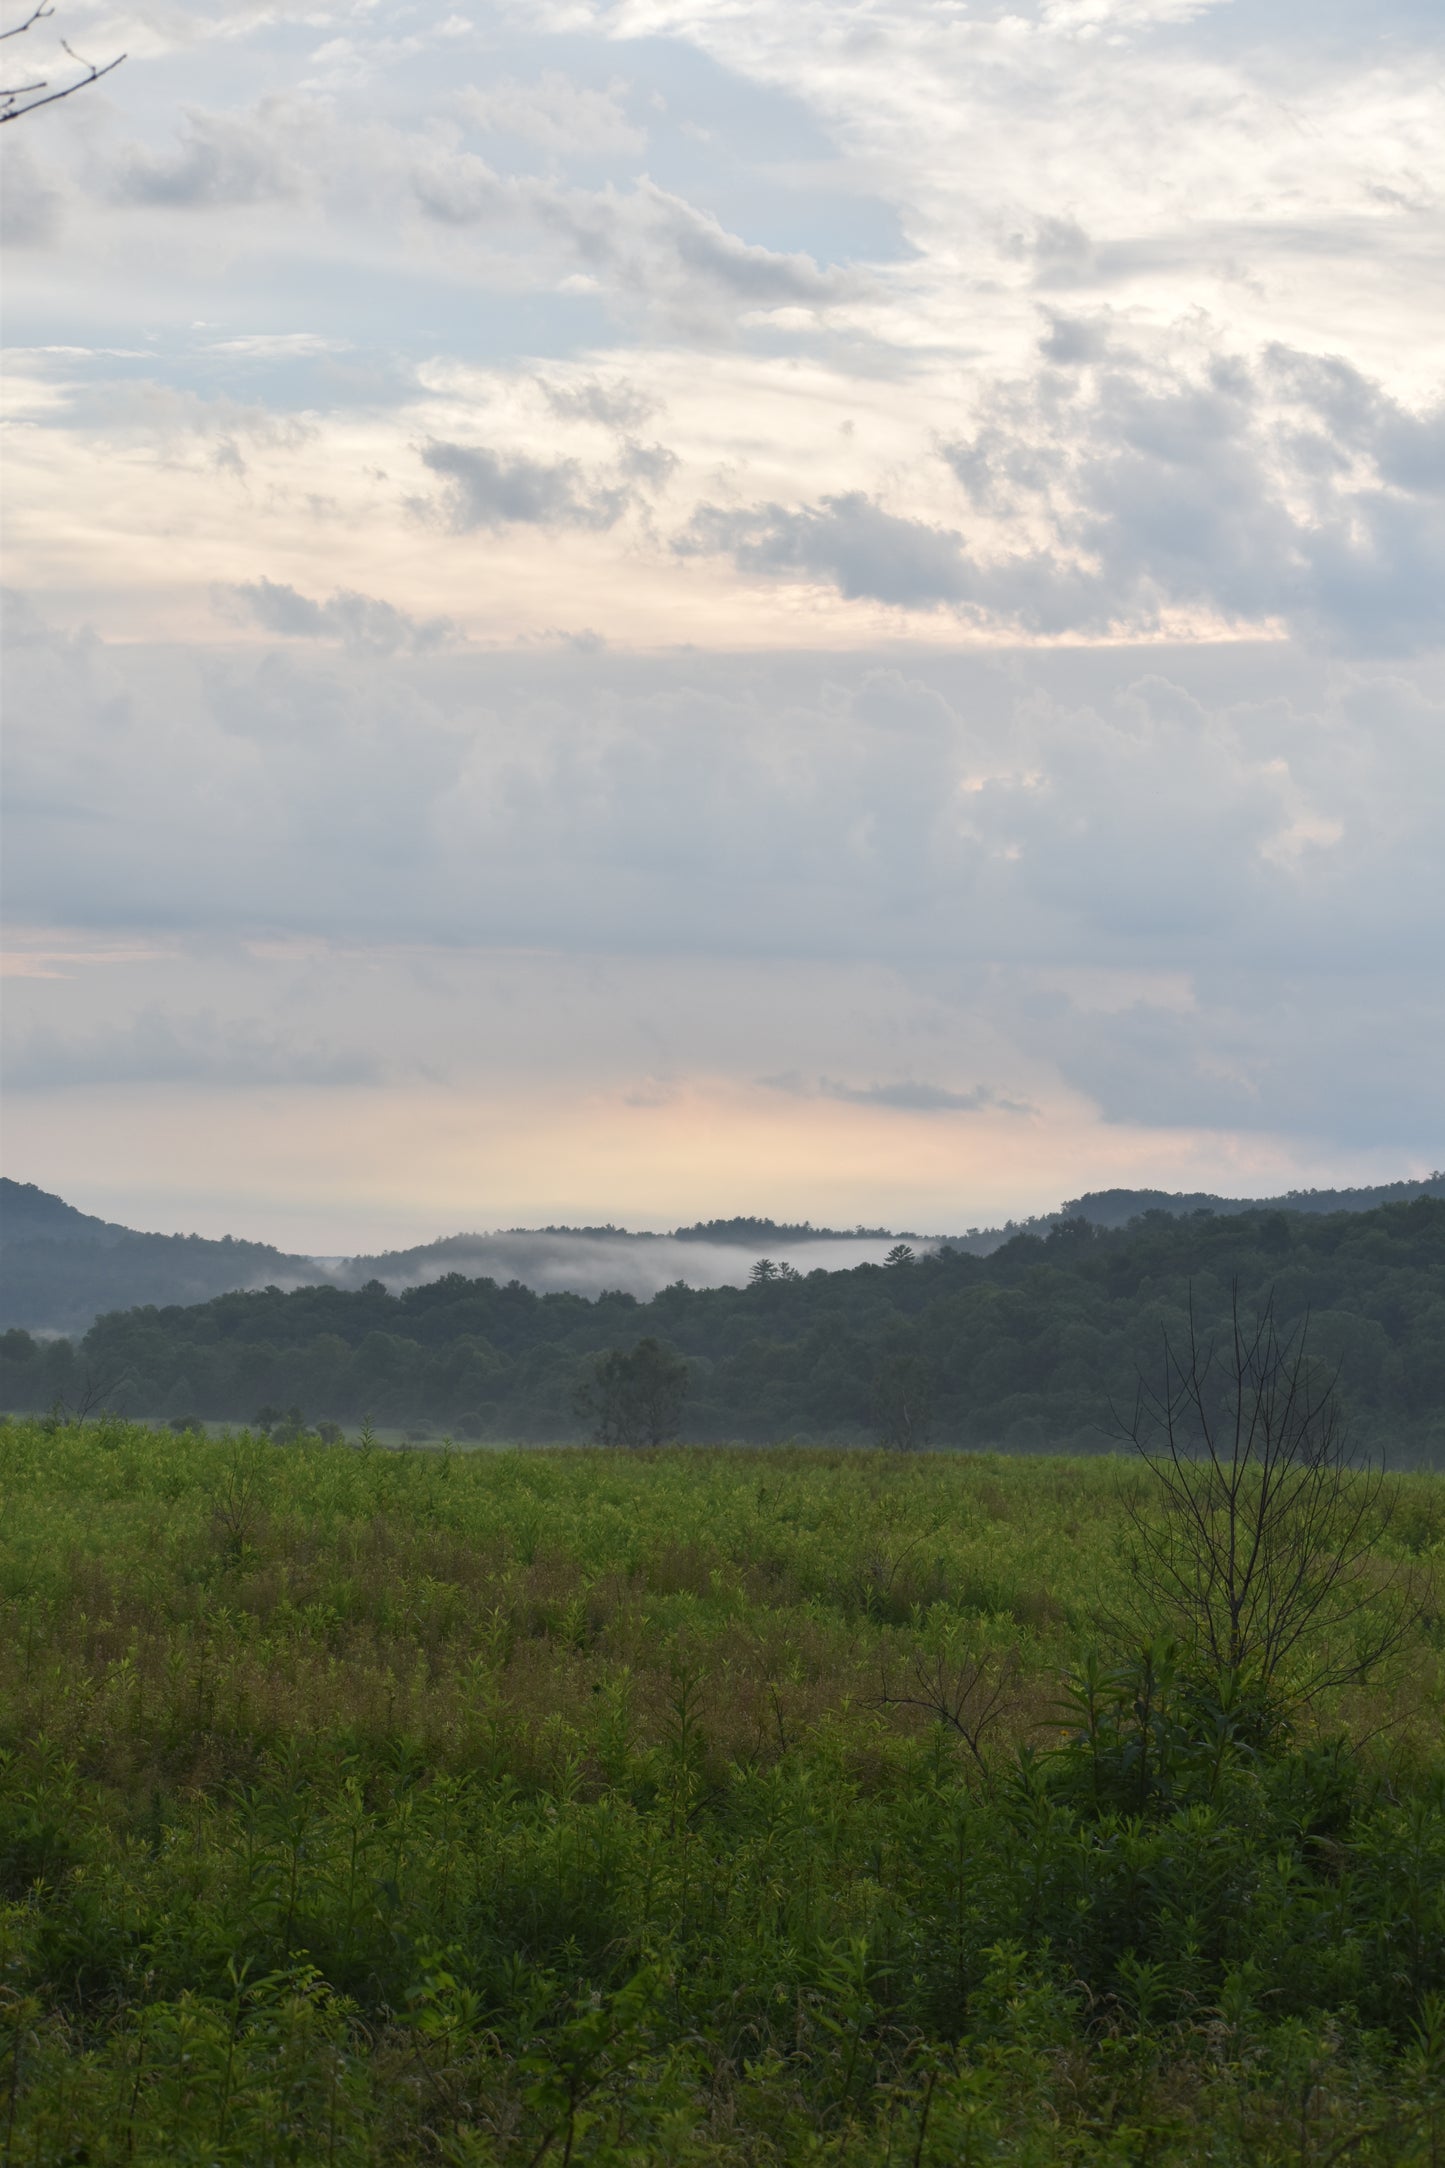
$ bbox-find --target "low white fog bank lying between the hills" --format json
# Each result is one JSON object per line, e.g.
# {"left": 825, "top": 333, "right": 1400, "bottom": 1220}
{"left": 316, "top": 1234, "right": 948, "bottom": 1301}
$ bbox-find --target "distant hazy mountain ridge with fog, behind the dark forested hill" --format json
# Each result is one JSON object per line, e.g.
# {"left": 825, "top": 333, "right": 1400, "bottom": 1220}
{"left": 0, "top": 1173, "right": 1445, "bottom": 1333}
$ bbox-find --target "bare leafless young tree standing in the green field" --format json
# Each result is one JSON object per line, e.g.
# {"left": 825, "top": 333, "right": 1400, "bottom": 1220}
{"left": 1127, "top": 1290, "right": 1419, "bottom": 1711}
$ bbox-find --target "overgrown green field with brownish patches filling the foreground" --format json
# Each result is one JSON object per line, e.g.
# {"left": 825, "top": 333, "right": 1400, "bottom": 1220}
{"left": 0, "top": 1420, "right": 1445, "bottom": 2168}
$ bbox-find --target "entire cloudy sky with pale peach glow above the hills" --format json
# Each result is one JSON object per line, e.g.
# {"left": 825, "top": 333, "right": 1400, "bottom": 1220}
{"left": 0, "top": 0, "right": 1445, "bottom": 1253}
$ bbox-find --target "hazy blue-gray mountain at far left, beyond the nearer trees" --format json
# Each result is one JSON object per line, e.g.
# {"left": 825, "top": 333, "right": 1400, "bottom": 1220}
{"left": 0, "top": 1175, "right": 323, "bottom": 1333}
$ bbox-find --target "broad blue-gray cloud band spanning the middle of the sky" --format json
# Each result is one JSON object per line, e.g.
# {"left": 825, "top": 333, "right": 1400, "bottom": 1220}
{"left": 4, "top": 596, "right": 1445, "bottom": 1158}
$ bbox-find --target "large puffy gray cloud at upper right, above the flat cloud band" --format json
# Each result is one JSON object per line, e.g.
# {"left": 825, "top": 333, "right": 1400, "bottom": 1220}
{"left": 676, "top": 333, "right": 1445, "bottom": 653}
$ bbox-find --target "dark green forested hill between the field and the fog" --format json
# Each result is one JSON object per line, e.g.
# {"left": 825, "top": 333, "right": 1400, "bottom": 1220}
{"left": 0, "top": 1197, "right": 1445, "bottom": 1466}
